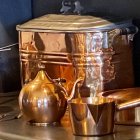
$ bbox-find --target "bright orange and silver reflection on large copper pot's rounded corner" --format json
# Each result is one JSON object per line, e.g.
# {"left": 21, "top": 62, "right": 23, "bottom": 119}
{"left": 69, "top": 32, "right": 115, "bottom": 96}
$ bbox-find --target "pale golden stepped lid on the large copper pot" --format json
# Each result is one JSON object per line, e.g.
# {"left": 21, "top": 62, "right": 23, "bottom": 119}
{"left": 17, "top": 14, "right": 131, "bottom": 32}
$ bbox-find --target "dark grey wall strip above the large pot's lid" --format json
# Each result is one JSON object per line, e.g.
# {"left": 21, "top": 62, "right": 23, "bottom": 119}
{"left": 33, "top": 0, "right": 140, "bottom": 18}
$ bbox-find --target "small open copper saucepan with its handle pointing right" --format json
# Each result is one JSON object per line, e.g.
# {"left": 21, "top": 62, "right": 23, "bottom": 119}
{"left": 68, "top": 97, "right": 140, "bottom": 136}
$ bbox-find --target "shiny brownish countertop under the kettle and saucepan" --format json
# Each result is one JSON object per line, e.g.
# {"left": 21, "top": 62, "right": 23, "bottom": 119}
{"left": 0, "top": 96, "right": 140, "bottom": 140}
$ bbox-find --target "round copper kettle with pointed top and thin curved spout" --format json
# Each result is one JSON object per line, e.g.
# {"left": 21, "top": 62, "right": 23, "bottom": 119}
{"left": 19, "top": 64, "right": 81, "bottom": 125}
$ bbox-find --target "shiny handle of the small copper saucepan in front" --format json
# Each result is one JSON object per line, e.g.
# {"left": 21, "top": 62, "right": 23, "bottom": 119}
{"left": 116, "top": 98, "right": 140, "bottom": 111}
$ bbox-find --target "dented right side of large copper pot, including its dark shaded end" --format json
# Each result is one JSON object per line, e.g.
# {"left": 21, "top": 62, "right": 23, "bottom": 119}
{"left": 68, "top": 30, "right": 134, "bottom": 96}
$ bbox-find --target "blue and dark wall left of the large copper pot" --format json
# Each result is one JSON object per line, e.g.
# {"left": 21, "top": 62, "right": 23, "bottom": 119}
{"left": 0, "top": 0, "right": 32, "bottom": 94}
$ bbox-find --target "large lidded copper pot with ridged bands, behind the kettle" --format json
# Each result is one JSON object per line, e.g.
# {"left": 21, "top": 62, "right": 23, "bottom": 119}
{"left": 17, "top": 14, "right": 137, "bottom": 96}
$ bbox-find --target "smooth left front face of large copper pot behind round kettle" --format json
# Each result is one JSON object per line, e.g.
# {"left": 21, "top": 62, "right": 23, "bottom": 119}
{"left": 19, "top": 32, "right": 75, "bottom": 94}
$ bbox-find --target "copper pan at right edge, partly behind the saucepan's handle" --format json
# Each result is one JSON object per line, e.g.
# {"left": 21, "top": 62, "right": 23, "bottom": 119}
{"left": 101, "top": 88, "right": 140, "bottom": 125}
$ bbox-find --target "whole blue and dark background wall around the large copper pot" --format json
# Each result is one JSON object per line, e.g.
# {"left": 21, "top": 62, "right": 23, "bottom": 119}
{"left": 0, "top": 0, "right": 140, "bottom": 92}
